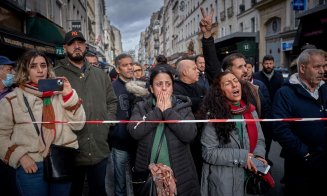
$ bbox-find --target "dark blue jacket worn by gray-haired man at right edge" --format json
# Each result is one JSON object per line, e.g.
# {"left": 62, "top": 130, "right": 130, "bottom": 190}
{"left": 272, "top": 78, "right": 327, "bottom": 159}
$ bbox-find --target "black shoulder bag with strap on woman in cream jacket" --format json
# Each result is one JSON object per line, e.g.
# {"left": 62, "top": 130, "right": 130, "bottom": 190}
{"left": 24, "top": 96, "right": 79, "bottom": 182}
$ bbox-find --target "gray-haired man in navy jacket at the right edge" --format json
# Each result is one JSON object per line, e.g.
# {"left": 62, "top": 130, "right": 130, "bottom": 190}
{"left": 272, "top": 49, "right": 327, "bottom": 195}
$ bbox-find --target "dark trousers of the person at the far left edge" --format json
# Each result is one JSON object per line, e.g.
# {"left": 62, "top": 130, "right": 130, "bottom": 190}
{"left": 0, "top": 160, "right": 19, "bottom": 196}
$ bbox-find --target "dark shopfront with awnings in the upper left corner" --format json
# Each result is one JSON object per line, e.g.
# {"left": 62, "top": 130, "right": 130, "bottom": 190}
{"left": 0, "top": 1, "right": 65, "bottom": 60}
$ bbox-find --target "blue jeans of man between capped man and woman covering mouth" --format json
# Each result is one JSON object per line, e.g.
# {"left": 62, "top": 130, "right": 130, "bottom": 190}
{"left": 112, "top": 148, "right": 130, "bottom": 196}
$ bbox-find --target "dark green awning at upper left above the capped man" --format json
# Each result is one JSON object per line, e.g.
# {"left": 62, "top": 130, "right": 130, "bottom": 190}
{"left": 26, "top": 13, "right": 65, "bottom": 45}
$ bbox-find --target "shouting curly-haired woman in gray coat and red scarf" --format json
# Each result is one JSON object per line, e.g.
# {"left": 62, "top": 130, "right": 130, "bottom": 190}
{"left": 198, "top": 72, "right": 267, "bottom": 196}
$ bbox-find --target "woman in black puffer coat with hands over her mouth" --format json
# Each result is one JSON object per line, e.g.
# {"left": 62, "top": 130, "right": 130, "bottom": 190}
{"left": 128, "top": 67, "right": 200, "bottom": 196}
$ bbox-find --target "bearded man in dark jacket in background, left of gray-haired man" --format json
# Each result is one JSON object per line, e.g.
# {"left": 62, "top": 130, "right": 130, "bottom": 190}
{"left": 253, "top": 55, "right": 284, "bottom": 102}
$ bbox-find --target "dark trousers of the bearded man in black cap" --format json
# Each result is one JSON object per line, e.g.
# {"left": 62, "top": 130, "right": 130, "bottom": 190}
{"left": 70, "top": 158, "right": 108, "bottom": 196}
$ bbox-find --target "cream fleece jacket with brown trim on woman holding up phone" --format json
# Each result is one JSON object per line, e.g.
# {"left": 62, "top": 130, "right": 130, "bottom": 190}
{"left": 0, "top": 88, "right": 86, "bottom": 168}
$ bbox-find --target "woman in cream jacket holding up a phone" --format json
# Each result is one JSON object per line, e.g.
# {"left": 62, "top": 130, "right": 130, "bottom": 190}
{"left": 0, "top": 50, "right": 85, "bottom": 196}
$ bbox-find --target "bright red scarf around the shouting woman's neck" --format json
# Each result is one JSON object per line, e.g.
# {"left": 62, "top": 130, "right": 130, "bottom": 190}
{"left": 229, "top": 100, "right": 258, "bottom": 153}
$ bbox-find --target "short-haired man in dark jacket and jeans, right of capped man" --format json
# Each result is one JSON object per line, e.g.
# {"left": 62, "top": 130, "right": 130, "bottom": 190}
{"left": 109, "top": 54, "right": 135, "bottom": 196}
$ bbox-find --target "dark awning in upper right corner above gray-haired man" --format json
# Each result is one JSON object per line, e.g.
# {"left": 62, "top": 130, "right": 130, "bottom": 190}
{"left": 293, "top": 5, "right": 327, "bottom": 52}
